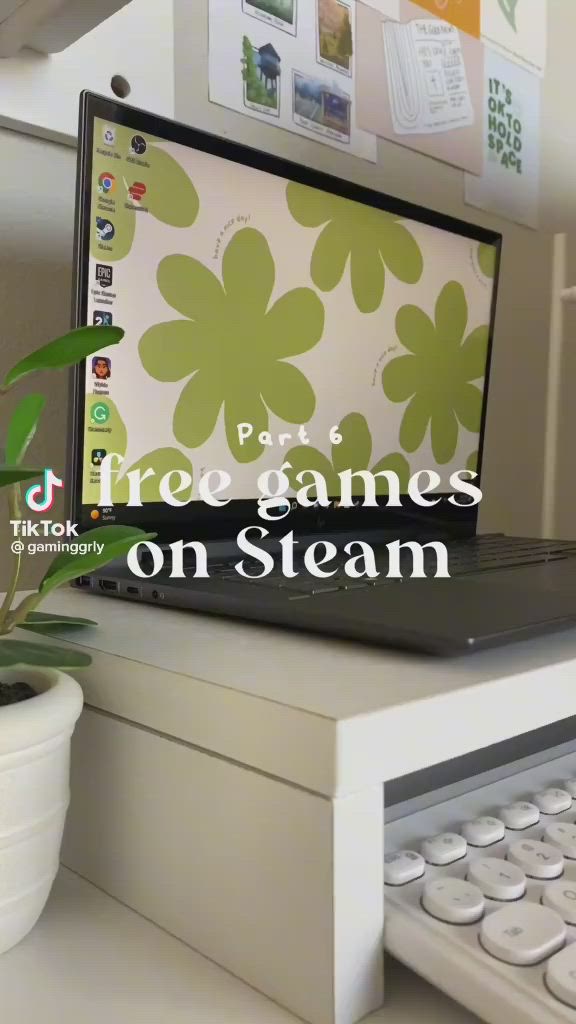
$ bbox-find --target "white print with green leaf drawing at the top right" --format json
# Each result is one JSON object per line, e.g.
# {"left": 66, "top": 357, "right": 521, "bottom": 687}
{"left": 482, "top": 0, "right": 547, "bottom": 77}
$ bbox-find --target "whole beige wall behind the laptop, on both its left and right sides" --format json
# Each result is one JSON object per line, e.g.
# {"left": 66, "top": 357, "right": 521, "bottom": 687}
{"left": 0, "top": 0, "right": 576, "bottom": 590}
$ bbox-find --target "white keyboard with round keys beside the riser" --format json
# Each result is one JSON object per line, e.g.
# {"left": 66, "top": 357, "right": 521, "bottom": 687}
{"left": 384, "top": 753, "right": 576, "bottom": 1024}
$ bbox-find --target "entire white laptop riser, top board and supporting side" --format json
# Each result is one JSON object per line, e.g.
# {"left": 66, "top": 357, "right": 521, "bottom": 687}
{"left": 19, "top": 591, "right": 576, "bottom": 1024}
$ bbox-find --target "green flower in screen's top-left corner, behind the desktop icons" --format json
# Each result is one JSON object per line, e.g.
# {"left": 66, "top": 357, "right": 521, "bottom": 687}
{"left": 90, "top": 122, "right": 200, "bottom": 263}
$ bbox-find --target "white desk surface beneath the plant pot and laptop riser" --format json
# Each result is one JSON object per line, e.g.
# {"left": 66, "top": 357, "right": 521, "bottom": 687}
{"left": 0, "top": 870, "right": 478, "bottom": 1024}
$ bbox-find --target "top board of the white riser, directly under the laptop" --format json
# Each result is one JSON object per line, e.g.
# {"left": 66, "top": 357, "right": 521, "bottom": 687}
{"left": 25, "top": 590, "right": 576, "bottom": 797}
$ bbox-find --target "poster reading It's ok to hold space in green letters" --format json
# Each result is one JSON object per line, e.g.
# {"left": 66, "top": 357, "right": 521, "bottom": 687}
{"left": 465, "top": 51, "right": 541, "bottom": 227}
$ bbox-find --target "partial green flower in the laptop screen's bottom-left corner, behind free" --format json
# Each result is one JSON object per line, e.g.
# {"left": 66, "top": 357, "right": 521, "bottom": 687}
{"left": 83, "top": 395, "right": 194, "bottom": 505}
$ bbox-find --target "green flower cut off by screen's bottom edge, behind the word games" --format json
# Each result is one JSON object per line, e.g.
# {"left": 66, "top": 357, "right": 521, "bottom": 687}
{"left": 286, "top": 413, "right": 410, "bottom": 498}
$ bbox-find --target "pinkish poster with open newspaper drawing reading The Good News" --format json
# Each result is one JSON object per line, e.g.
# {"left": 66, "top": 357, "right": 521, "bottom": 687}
{"left": 356, "top": 0, "right": 484, "bottom": 174}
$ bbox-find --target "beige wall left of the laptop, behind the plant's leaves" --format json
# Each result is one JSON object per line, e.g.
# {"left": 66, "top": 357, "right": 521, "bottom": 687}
{"left": 0, "top": 129, "right": 76, "bottom": 591}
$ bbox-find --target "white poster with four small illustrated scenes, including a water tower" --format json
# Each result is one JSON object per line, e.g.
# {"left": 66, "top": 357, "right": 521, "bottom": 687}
{"left": 209, "top": 0, "right": 377, "bottom": 163}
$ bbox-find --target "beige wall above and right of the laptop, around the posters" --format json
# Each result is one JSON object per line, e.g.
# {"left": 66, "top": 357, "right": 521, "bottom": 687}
{"left": 175, "top": 0, "right": 565, "bottom": 535}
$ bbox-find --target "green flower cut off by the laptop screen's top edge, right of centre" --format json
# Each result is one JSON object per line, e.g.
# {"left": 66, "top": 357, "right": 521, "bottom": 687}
{"left": 286, "top": 182, "right": 423, "bottom": 313}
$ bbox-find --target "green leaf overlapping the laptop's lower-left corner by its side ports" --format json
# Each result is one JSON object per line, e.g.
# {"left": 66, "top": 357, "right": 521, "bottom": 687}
{"left": 39, "top": 524, "right": 157, "bottom": 597}
